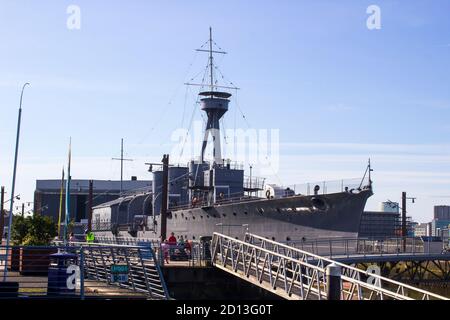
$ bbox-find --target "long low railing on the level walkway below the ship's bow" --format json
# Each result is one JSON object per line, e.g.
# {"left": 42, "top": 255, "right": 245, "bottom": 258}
{"left": 283, "top": 237, "right": 425, "bottom": 258}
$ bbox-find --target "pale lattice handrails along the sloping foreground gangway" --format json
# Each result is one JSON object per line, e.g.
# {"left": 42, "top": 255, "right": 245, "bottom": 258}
{"left": 212, "top": 233, "right": 449, "bottom": 300}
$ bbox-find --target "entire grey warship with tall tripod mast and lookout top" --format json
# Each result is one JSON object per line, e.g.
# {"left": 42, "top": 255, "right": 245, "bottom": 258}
{"left": 92, "top": 29, "right": 373, "bottom": 241}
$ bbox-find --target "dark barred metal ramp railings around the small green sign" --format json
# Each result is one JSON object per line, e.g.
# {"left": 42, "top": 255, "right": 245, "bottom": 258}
{"left": 82, "top": 243, "right": 169, "bottom": 299}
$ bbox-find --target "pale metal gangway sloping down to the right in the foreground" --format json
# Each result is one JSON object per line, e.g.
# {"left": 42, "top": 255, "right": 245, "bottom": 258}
{"left": 211, "top": 233, "right": 449, "bottom": 300}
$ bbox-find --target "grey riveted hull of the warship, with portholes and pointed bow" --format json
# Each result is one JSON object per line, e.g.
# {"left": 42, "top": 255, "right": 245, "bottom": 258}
{"left": 106, "top": 189, "right": 373, "bottom": 241}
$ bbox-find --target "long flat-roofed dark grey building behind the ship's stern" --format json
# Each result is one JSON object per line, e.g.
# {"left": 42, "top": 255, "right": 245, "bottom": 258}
{"left": 34, "top": 177, "right": 152, "bottom": 222}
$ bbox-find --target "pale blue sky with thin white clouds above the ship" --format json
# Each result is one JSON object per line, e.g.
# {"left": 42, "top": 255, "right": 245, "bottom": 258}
{"left": 0, "top": 0, "right": 450, "bottom": 221}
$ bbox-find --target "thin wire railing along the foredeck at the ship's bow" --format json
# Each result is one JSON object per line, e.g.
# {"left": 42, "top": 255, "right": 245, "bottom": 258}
{"left": 283, "top": 177, "right": 369, "bottom": 196}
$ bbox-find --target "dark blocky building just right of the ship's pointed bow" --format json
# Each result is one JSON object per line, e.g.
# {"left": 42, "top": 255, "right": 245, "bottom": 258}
{"left": 359, "top": 202, "right": 402, "bottom": 239}
